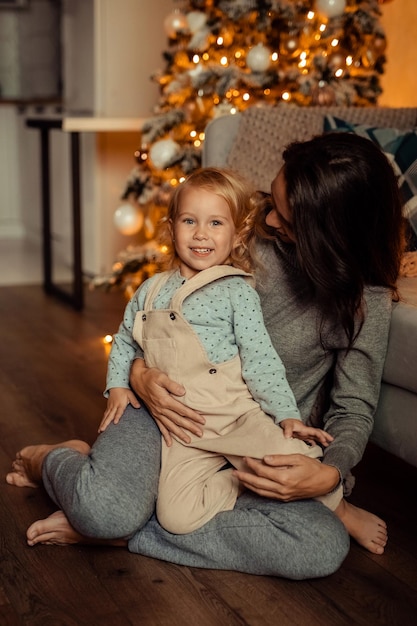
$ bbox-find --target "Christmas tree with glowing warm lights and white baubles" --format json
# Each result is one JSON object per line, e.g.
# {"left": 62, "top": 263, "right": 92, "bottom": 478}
{"left": 96, "top": 0, "right": 386, "bottom": 292}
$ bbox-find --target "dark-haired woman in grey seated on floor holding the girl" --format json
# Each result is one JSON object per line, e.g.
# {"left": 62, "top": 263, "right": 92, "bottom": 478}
{"left": 8, "top": 133, "right": 404, "bottom": 579}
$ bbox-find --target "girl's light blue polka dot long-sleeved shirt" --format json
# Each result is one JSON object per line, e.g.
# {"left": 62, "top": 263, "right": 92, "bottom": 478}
{"left": 105, "top": 272, "right": 300, "bottom": 422}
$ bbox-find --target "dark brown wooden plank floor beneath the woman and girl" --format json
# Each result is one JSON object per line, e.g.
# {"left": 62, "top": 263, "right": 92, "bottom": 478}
{"left": 0, "top": 286, "right": 417, "bottom": 626}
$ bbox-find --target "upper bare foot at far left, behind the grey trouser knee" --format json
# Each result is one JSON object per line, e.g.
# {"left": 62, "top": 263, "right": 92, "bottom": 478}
{"left": 6, "top": 439, "right": 90, "bottom": 487}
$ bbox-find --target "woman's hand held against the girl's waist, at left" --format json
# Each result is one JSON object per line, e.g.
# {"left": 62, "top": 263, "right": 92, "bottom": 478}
{"left": 130, "top": 359, "right": 205, "bottom": 446}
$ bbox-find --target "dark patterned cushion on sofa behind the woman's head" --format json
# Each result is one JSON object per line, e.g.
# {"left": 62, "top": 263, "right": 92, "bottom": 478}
{"left": 324, "top": 115, "right": 417, "bottom": 247}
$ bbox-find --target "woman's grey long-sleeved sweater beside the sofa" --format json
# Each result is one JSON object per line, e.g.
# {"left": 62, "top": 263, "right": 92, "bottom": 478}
{"left": 257, "top": 241, "right": 392, "bottom": 477}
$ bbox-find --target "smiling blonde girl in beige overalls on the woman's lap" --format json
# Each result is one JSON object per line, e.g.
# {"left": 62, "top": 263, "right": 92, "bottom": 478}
{"left": 100, "top": 168, "right": 354, "bottom": 534}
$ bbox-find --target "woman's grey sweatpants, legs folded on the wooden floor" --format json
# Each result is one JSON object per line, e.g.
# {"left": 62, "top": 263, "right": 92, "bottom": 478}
{"left": 43, "top": 405, "right": 349, "bottom": 579}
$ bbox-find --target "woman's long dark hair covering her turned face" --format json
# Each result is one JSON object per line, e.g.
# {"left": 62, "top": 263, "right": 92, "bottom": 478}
{"left": 270, "top": 133, "right": 405, "bottom": 347}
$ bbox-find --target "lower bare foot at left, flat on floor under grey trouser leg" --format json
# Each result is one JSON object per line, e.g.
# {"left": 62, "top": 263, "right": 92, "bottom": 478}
{"left": 26, "top": 511, "right": 127, "bottom": 547}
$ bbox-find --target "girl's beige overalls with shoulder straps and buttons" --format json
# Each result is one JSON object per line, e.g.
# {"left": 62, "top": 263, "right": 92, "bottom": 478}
{"left": 133, "top": 266, "right": 341, "bottom": 534}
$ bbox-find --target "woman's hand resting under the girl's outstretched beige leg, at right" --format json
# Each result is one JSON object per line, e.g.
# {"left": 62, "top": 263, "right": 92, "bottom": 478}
{"left": 233, "top": 454, "right": 340, "bottom": 502}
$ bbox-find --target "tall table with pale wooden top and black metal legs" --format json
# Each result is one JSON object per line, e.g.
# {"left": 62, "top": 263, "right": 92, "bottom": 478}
{"left": 26, "top": 116, "right": 144, "bottom": 310}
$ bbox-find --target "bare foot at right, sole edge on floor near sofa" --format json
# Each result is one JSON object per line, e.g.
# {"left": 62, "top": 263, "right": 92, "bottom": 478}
{"left": 335, "top": 500, "right": 388, "bottom": 554}
